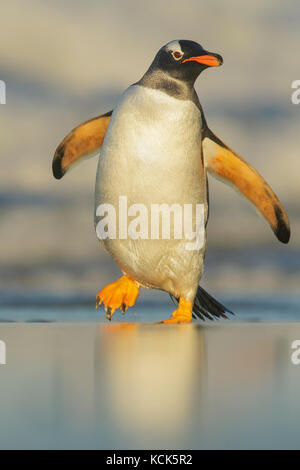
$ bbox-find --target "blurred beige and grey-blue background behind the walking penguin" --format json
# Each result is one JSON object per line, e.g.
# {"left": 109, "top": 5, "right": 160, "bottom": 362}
{"left": 0, "top": 0, "right": 300, "bottom": 300}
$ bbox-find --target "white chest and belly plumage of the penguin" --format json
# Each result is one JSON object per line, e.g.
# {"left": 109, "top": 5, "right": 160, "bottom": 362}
{"left": 95, "top": 85, "right": 207, "bottom": 298}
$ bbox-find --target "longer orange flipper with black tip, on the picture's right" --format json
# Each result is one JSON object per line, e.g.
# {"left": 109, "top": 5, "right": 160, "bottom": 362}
{"left": 202, "top": 128, "right": 290, "bottom": 243}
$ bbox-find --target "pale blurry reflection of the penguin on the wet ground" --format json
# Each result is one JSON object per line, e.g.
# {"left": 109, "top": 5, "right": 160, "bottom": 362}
{"left": 96, "top": 323, "right": 205, "bottom": 437}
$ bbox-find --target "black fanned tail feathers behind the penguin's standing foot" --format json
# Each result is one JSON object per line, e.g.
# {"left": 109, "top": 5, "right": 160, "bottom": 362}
{"left": 171, "top": 286, "right": 234, "bottom": 321}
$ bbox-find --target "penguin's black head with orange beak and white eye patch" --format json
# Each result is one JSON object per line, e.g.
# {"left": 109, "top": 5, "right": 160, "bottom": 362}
{"left": 150, "top": 40, "right": 223, "bottom": 84}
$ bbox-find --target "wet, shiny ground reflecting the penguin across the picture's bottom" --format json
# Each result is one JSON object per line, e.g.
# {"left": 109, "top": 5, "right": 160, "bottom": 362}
{"left": 0, "top": 305, "right": 300, "bottom": 449}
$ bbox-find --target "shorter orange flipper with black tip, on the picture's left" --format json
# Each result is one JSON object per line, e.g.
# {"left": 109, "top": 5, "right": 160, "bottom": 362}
{"left": 52, "top": 111, "right": 112, "bottom": 179}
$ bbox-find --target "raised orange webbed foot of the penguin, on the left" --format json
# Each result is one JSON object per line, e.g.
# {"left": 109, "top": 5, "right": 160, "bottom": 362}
{"left": 96, "top": 276, "right": 139, "bottom": 320}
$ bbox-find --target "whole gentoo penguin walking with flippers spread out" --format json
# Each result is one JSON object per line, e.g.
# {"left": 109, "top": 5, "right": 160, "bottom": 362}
{"left": 53, "top": 40, "right": 290, "bottom": 323}
